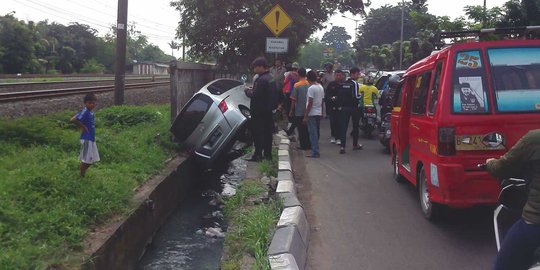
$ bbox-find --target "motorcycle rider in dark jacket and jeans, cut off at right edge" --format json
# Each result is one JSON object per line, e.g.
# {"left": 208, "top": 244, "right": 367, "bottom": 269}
{"left": 486, "top": 129, "right": 540, "bottom": 270}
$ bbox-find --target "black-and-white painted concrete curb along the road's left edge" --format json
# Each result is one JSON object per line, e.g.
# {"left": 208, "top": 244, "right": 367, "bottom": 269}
{"left": 268, "top": 132, "right": 309, "bottom": 270}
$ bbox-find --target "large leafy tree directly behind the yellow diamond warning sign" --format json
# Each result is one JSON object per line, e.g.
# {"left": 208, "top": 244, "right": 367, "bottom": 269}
{"left": 171, "top": 0, "right": 370, "bottom": 69}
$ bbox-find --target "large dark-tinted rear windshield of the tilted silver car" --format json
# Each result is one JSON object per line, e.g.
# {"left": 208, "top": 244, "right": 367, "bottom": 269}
{"left": 171, "top": 94, "right": 213, "bottom": 142}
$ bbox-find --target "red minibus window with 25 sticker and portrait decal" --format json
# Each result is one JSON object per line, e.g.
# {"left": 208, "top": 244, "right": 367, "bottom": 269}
{"left": 452, "top": 50, "right": 489, "bottom": 114}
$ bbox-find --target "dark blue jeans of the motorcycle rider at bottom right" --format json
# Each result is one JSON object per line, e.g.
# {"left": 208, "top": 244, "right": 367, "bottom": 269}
{"left": 493, "top": 218, "right": 540, "bottom": 270}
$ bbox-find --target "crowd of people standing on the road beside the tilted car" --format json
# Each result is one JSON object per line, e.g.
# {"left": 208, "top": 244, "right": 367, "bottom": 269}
{"left": 246, "top": 57, "right": 378, "bottom": 161}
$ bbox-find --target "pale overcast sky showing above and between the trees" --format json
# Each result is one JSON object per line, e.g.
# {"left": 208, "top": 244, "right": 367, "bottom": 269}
{"left": 0, "top": 0, "right": 507, "bottom": 57}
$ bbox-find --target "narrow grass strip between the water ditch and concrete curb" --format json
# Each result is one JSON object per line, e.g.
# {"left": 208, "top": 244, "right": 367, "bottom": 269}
{"left": 221, "top": 150, "right": 283, "bottom": 270}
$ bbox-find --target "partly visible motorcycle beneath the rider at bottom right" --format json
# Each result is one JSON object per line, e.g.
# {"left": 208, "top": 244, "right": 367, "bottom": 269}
{"left": 478, "top": 164, "right": 540, "bottom": 270}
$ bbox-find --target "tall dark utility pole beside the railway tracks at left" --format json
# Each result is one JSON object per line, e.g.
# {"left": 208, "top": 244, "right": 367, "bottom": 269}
{"left": 114, "top": 0, "right": 128, "bottom": 105}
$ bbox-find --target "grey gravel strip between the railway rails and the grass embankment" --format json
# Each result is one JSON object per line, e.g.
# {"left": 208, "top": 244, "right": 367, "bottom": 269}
{"left": 0, "top": 85, "right": 170, "bottom": 117}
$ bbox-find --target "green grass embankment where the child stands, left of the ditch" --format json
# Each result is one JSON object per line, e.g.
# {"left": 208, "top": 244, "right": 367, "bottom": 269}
{"left": 0, "top": 106, "right": 176, "bottom": 269}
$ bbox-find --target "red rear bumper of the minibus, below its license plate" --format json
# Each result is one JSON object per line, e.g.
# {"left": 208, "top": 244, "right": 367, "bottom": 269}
{"left": 429, "top": 164, "right": 500, "bottom": 208}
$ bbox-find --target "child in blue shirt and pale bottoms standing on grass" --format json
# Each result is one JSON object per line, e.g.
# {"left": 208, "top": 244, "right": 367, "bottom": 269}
{"left": 70, "top": 94, "right": 99, "bottom": 177}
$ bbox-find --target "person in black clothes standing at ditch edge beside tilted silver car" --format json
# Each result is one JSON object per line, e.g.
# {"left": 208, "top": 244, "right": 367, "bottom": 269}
{"left": 246, "top": 57, "right": 275, "bottom": 162}
